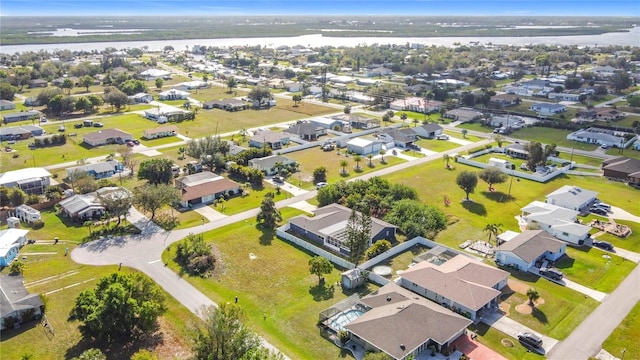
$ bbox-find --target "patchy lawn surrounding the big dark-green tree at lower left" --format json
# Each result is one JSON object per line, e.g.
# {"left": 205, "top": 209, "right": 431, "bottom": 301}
{"left": 0, "top": 243, "right": 199, "bottom": 360}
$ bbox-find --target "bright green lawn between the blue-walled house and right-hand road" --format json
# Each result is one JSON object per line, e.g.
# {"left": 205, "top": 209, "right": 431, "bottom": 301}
{"left": 556, "top": 247, "right": 636, "bottom": 293}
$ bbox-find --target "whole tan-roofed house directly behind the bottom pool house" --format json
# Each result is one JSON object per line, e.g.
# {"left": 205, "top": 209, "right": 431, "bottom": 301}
{"left": 399, "top": 254, "right": 509, "bottom": 320}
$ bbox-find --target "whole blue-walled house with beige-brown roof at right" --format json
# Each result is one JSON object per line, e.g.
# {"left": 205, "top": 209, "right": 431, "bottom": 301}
{"left": 495, "top": 230, "right": 567, "bottom": 271}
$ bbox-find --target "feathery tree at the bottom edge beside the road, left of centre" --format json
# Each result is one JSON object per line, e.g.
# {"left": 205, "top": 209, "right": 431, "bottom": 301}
{"left": 192, "top": 302, "right": 272, "bottom": 360}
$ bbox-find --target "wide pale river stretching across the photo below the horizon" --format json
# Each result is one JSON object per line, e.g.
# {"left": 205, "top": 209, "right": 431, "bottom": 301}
{"left": 0, "top": 27, "right": 640, "bottom": 54}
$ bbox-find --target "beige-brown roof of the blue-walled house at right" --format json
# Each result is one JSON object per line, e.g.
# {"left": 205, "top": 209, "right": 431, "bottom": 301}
{"left": 497, "top": 230, "right": 564, "bottom": 263}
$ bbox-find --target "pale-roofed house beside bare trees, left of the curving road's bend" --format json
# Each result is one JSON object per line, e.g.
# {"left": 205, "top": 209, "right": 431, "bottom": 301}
{"left": 58, "top": 186, "right": 131, "bottom": 221}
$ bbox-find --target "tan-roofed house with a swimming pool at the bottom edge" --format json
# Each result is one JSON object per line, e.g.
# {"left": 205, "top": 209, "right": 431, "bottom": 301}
{"left": 344, "top": 282, "right": 472, "bottom": 360}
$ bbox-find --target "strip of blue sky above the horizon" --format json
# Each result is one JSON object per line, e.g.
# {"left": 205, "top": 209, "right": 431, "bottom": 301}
{"left": 0, "top": 0, "right": 640, "bottom": 16}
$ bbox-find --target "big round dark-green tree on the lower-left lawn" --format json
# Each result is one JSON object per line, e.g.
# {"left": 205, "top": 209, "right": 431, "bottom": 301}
{"left": 71, "top": 273, "right": 166, "bottom": 342}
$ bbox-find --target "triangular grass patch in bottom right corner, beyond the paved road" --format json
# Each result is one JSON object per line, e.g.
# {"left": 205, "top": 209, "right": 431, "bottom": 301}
{"left": 602, "top": 303, "right": 640, "bottom": 359}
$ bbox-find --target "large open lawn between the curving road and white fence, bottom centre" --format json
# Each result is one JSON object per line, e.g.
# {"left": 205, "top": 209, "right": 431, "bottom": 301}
{"left": 163, "top": 209, "right": 374, "bottom": 359}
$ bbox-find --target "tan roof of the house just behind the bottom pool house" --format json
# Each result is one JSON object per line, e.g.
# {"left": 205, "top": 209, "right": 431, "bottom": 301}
{"left": 401, "top": 255, "right": 509, "bottom": 311}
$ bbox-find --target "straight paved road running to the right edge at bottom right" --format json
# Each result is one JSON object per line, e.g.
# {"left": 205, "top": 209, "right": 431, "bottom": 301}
{"left": 547, "top": 266, "right": 640, "bottom": 360}
